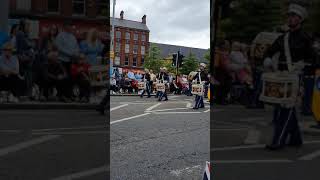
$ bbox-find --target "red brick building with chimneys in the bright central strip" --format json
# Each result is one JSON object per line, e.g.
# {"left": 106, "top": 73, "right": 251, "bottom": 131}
{"left": 110, "top": 11, "right": 150, "bottom": 71}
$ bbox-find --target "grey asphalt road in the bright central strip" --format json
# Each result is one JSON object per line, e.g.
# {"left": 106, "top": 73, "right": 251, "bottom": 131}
{"left": 110, "top": 96, "right": 210, "bottom": 180}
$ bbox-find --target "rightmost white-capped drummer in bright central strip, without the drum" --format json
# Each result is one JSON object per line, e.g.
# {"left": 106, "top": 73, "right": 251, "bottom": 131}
{"left": 193, "top": 63, "right": 208, "bottom": 109}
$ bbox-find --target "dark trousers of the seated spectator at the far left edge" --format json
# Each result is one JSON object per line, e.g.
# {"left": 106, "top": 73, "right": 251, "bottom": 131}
{"left": 0, "top": 75, "right": 23, "bottom": 97}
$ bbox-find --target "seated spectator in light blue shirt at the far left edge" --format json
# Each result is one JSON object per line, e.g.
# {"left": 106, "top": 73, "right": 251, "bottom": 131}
{"left": 0, "top": 43, "right": 23, "bottom": 102}
